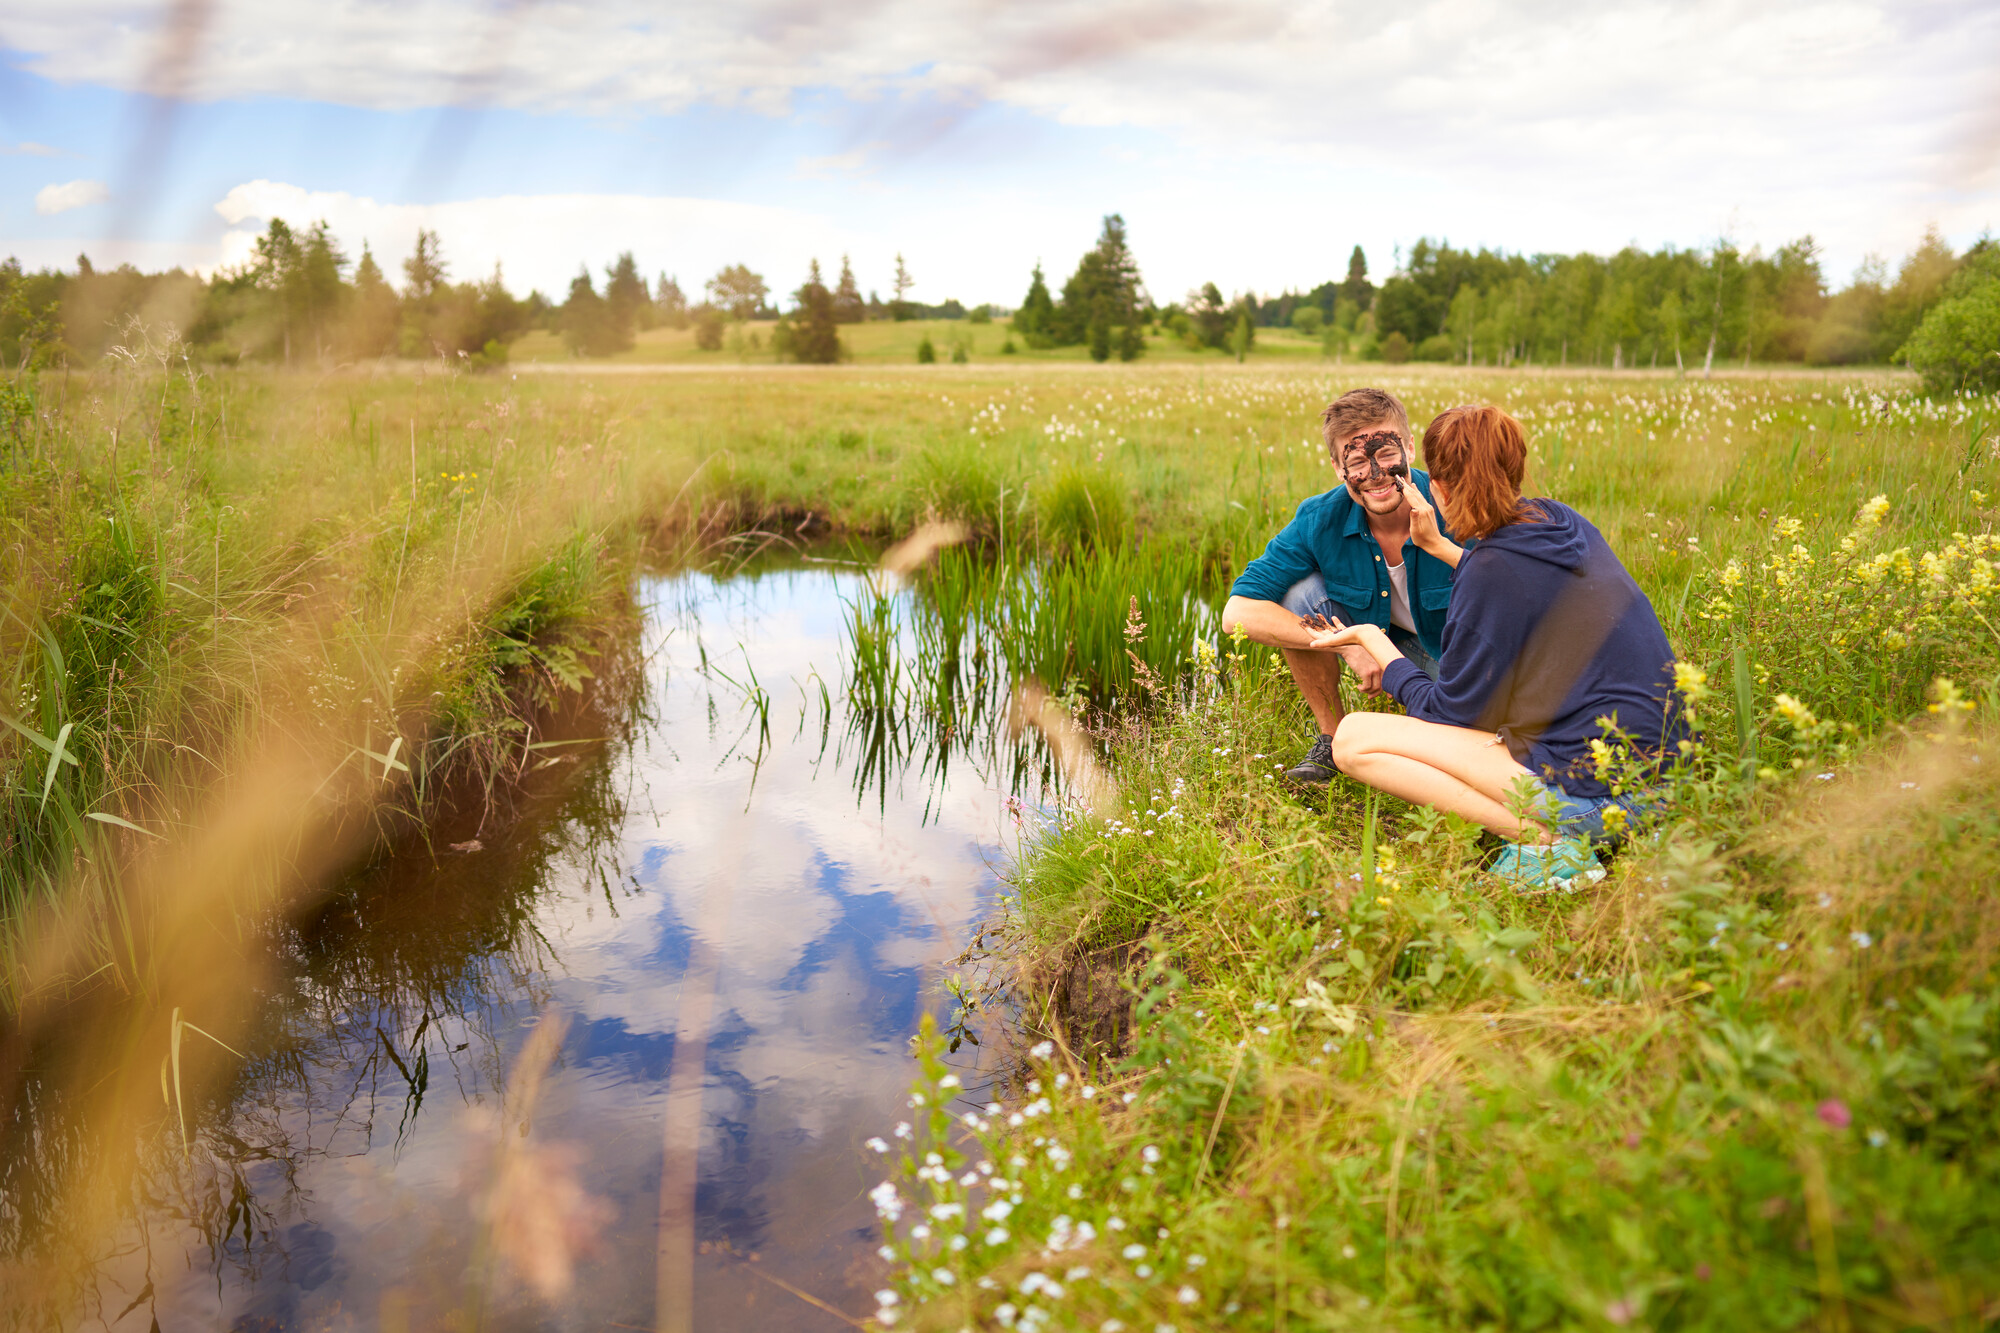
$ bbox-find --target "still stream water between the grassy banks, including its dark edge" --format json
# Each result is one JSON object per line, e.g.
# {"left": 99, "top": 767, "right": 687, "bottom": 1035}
{"left": 58, "top": 566, "right": 1040, "bottom": 1333}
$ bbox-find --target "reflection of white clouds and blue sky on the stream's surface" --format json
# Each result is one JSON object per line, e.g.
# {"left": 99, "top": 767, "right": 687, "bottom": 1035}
{"left": 113, "top": 568, "right": 1018, "bottom": 1331}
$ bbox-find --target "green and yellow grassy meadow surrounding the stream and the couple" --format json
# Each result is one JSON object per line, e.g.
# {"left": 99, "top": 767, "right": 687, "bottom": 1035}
{"left": 0, "top": 348, "right": 2000, "bottom": 1329}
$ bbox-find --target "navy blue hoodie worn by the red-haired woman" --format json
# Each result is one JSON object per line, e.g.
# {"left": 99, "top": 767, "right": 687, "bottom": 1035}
{"left": 1382, "top": 500, "right": 1688, "bottom": 797}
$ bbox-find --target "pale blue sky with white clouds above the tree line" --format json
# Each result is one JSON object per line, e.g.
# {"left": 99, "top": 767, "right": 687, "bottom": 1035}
{"left": 0, "top": 0, "right": 2000, "bottom": 306}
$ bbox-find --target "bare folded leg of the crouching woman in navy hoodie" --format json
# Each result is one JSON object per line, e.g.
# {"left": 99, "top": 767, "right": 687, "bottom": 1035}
{"left": 1334, "top": 713, "right": 1542, "bottom": 839}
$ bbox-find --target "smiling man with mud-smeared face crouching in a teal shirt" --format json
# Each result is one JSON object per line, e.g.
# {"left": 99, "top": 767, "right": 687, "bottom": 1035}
{"left": 1222, "top": 388, "right": 1452, "bottom": 783}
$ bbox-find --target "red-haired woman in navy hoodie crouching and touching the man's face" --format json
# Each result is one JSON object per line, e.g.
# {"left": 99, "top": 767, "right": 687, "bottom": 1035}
{"left": 1312, "top": 406, "right": 1686, "bottom": 889}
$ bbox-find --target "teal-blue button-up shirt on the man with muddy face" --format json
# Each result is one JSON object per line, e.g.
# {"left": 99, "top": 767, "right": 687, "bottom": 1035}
{"left": 1230, "top": 468, "right": 1452, "bottom": 658}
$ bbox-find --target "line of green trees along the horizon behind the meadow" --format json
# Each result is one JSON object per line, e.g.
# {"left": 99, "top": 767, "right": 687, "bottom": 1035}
{"left": 0, "top": 214, "right": 2000, "bottom": 384}
